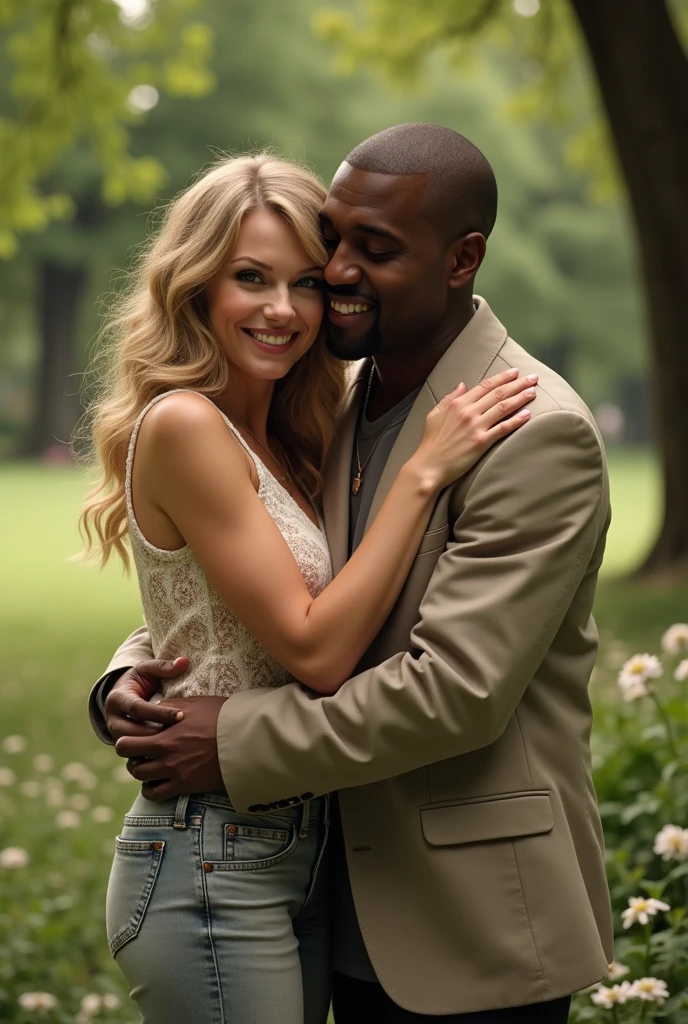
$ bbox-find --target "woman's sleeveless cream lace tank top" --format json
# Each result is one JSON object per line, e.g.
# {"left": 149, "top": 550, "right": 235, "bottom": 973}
{"left": 125, "top": 388, "right": 332, "bottom": 697}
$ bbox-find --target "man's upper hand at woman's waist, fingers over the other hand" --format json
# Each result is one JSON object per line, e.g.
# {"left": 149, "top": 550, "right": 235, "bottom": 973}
{"left": 105, "top": 657, "right": 188, "bottom": 741}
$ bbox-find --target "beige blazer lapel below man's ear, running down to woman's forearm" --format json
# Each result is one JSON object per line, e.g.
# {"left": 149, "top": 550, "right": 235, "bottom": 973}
{"left": 362, "top": 295, "right": 507, "bottom": 532}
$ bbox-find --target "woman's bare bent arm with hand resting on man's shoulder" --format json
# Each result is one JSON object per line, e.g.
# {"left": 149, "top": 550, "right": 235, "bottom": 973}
{"left": 135, "top": 374, "right": 532, "bottom": 693}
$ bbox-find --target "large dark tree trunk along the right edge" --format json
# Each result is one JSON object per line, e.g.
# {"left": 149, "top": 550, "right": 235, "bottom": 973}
{"left": 571, "top": 0, "right": 688, "bottom": 577}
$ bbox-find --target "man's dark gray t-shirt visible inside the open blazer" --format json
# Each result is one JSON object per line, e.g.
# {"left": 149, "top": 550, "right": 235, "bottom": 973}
{"left": 332, "top": 388, "right": 420, "bottom": 981}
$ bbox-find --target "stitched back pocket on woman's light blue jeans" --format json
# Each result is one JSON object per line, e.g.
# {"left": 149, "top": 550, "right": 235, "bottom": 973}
{"left": 105, "top": 836, "right": 165, "bottom": 956}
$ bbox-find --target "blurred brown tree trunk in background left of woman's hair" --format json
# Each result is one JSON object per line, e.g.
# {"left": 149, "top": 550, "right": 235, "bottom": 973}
{"left": 24, "top": 260, "right": 86, "bottom": 461}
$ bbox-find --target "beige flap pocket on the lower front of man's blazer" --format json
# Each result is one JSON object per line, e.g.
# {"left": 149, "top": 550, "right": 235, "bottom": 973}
{"left": 421, "top": 790, "right": 554, "bottom": 846}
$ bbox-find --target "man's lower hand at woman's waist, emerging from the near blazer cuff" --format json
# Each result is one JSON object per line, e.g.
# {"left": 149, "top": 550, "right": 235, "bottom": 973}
{"left": 115, "top": 696, "right": 227, "bottom": 800}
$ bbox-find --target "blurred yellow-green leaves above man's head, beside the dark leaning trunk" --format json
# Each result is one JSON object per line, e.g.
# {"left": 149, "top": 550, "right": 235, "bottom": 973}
{"left": 315, "top": 0, "right": 615, "bottom": 198}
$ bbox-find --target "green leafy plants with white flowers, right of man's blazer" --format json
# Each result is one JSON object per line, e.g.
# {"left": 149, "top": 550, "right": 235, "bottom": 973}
{"left": 571, "top": 626, "right": 688, "bottom": 1024}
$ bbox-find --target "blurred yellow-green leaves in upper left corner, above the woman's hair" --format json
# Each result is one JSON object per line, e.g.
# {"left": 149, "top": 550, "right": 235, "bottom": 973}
{"left": 0, "top": 0, "right": 214, "bottom": 257}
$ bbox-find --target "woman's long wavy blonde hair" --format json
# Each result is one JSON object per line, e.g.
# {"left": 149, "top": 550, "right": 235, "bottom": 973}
{"left": 80, "top": 153, "right": 346, "bottom": 566}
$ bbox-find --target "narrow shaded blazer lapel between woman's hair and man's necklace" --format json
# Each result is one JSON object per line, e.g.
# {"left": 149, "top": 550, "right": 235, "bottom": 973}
{"left": 323, "top": 359, "right": 371, "bottom": 575}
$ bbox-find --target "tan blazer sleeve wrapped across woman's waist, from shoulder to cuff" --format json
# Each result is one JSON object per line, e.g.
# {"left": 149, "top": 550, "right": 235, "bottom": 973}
{"left": 217, "top": 410, "right": 607, "bottom": 810}
